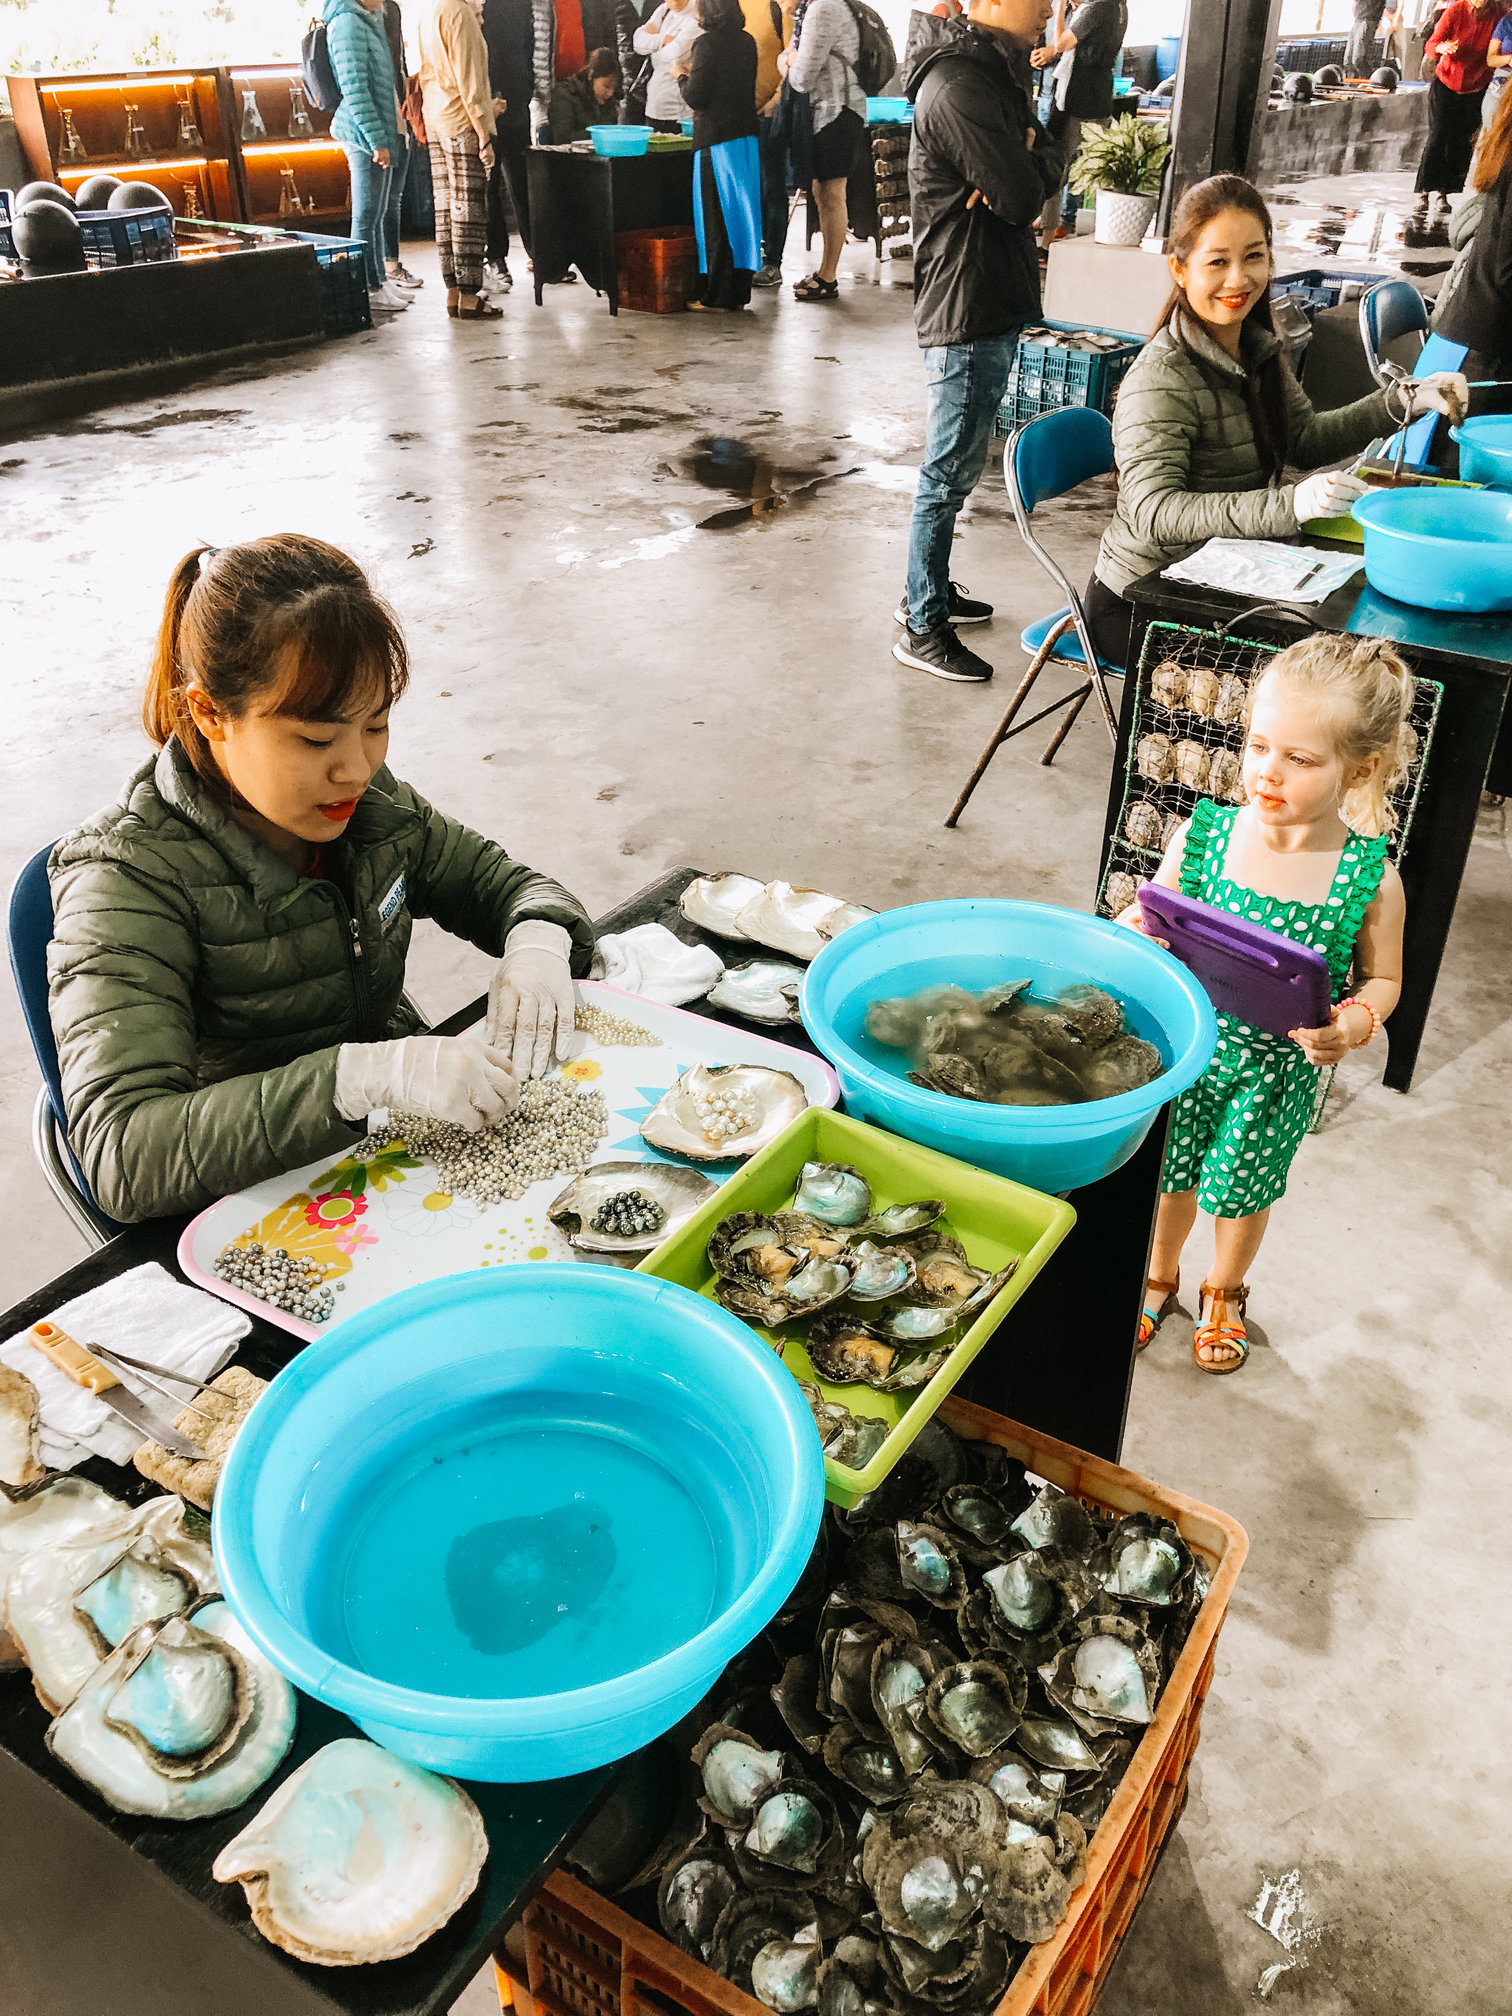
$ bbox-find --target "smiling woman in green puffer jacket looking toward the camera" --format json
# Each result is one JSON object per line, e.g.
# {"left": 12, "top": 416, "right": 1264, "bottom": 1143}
{"left": 1087, "top": 175, "right": 1466, "bottom": 665}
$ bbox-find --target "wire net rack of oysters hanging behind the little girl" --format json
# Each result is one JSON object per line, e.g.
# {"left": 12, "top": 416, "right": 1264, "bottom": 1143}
{"left": 1097, "top": 623, "right": 1443, "bottom": 917}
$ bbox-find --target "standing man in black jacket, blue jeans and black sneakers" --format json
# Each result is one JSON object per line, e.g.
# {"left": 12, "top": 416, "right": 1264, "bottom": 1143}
{"left": 893, "top": 0, "right": 1062, "bottom": 679}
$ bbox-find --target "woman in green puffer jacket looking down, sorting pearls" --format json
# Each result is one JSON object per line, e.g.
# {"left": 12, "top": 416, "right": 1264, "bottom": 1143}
{"left": 48, "top": 532, "right": 593, "bottom": 1224}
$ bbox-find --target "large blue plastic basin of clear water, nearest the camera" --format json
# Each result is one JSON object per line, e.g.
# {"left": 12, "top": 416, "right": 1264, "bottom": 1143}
{"left": 214, "top": 1264, "right": 825, "bottom": 1782}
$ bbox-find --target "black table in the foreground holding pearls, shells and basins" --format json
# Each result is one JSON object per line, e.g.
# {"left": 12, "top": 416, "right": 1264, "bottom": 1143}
{"left": 0, "top": 867, "right": 1165, "bottom": 2016}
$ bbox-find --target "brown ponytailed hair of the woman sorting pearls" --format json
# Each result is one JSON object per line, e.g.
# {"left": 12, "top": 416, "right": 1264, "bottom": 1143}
{"left": 141, "top": 532, "right": 409, "bottom": 794}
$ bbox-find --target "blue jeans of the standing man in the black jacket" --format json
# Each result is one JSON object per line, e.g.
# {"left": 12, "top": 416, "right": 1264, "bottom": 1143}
{"left": 905, "top": 329, "right": 1018, "bottom": 637}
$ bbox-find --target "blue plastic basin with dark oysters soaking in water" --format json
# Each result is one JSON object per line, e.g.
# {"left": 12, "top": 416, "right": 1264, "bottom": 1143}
{"left": 802, "top": 897, "right": 1218, "bottom": 1191}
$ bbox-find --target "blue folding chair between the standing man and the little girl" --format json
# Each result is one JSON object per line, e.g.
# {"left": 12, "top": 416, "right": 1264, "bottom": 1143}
{"left": 946, "top": 405, "right": 1123, "bottom": 827}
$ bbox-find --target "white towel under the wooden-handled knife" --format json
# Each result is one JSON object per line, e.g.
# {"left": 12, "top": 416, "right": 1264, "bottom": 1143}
{"left": 0, "top": 1260, "right": 252, "bottom": 1470}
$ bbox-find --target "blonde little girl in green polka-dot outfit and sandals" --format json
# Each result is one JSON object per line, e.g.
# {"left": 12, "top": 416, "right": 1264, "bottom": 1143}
{"left": 1119, "top": 635, "right": 1413, "bottom": 1373}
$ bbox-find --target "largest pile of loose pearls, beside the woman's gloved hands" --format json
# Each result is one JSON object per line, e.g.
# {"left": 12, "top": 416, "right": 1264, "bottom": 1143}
{"left": 363, "top": 1079, "right": 609, "bottom": 1204}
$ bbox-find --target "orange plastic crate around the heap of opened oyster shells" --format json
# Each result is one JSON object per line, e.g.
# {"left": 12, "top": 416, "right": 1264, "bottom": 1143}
{"left": 512, "top": 1395, "right": 1250, "bottom": 2016}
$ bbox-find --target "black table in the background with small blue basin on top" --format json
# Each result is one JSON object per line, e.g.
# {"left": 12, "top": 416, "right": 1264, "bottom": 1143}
{"left": 526, "top": 147, "right": 694, "bottom": 314}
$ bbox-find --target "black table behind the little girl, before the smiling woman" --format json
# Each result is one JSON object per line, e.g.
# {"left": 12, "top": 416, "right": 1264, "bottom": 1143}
{"left": 1099, "top": 576, "right": 1512, "bottom": 1093}
